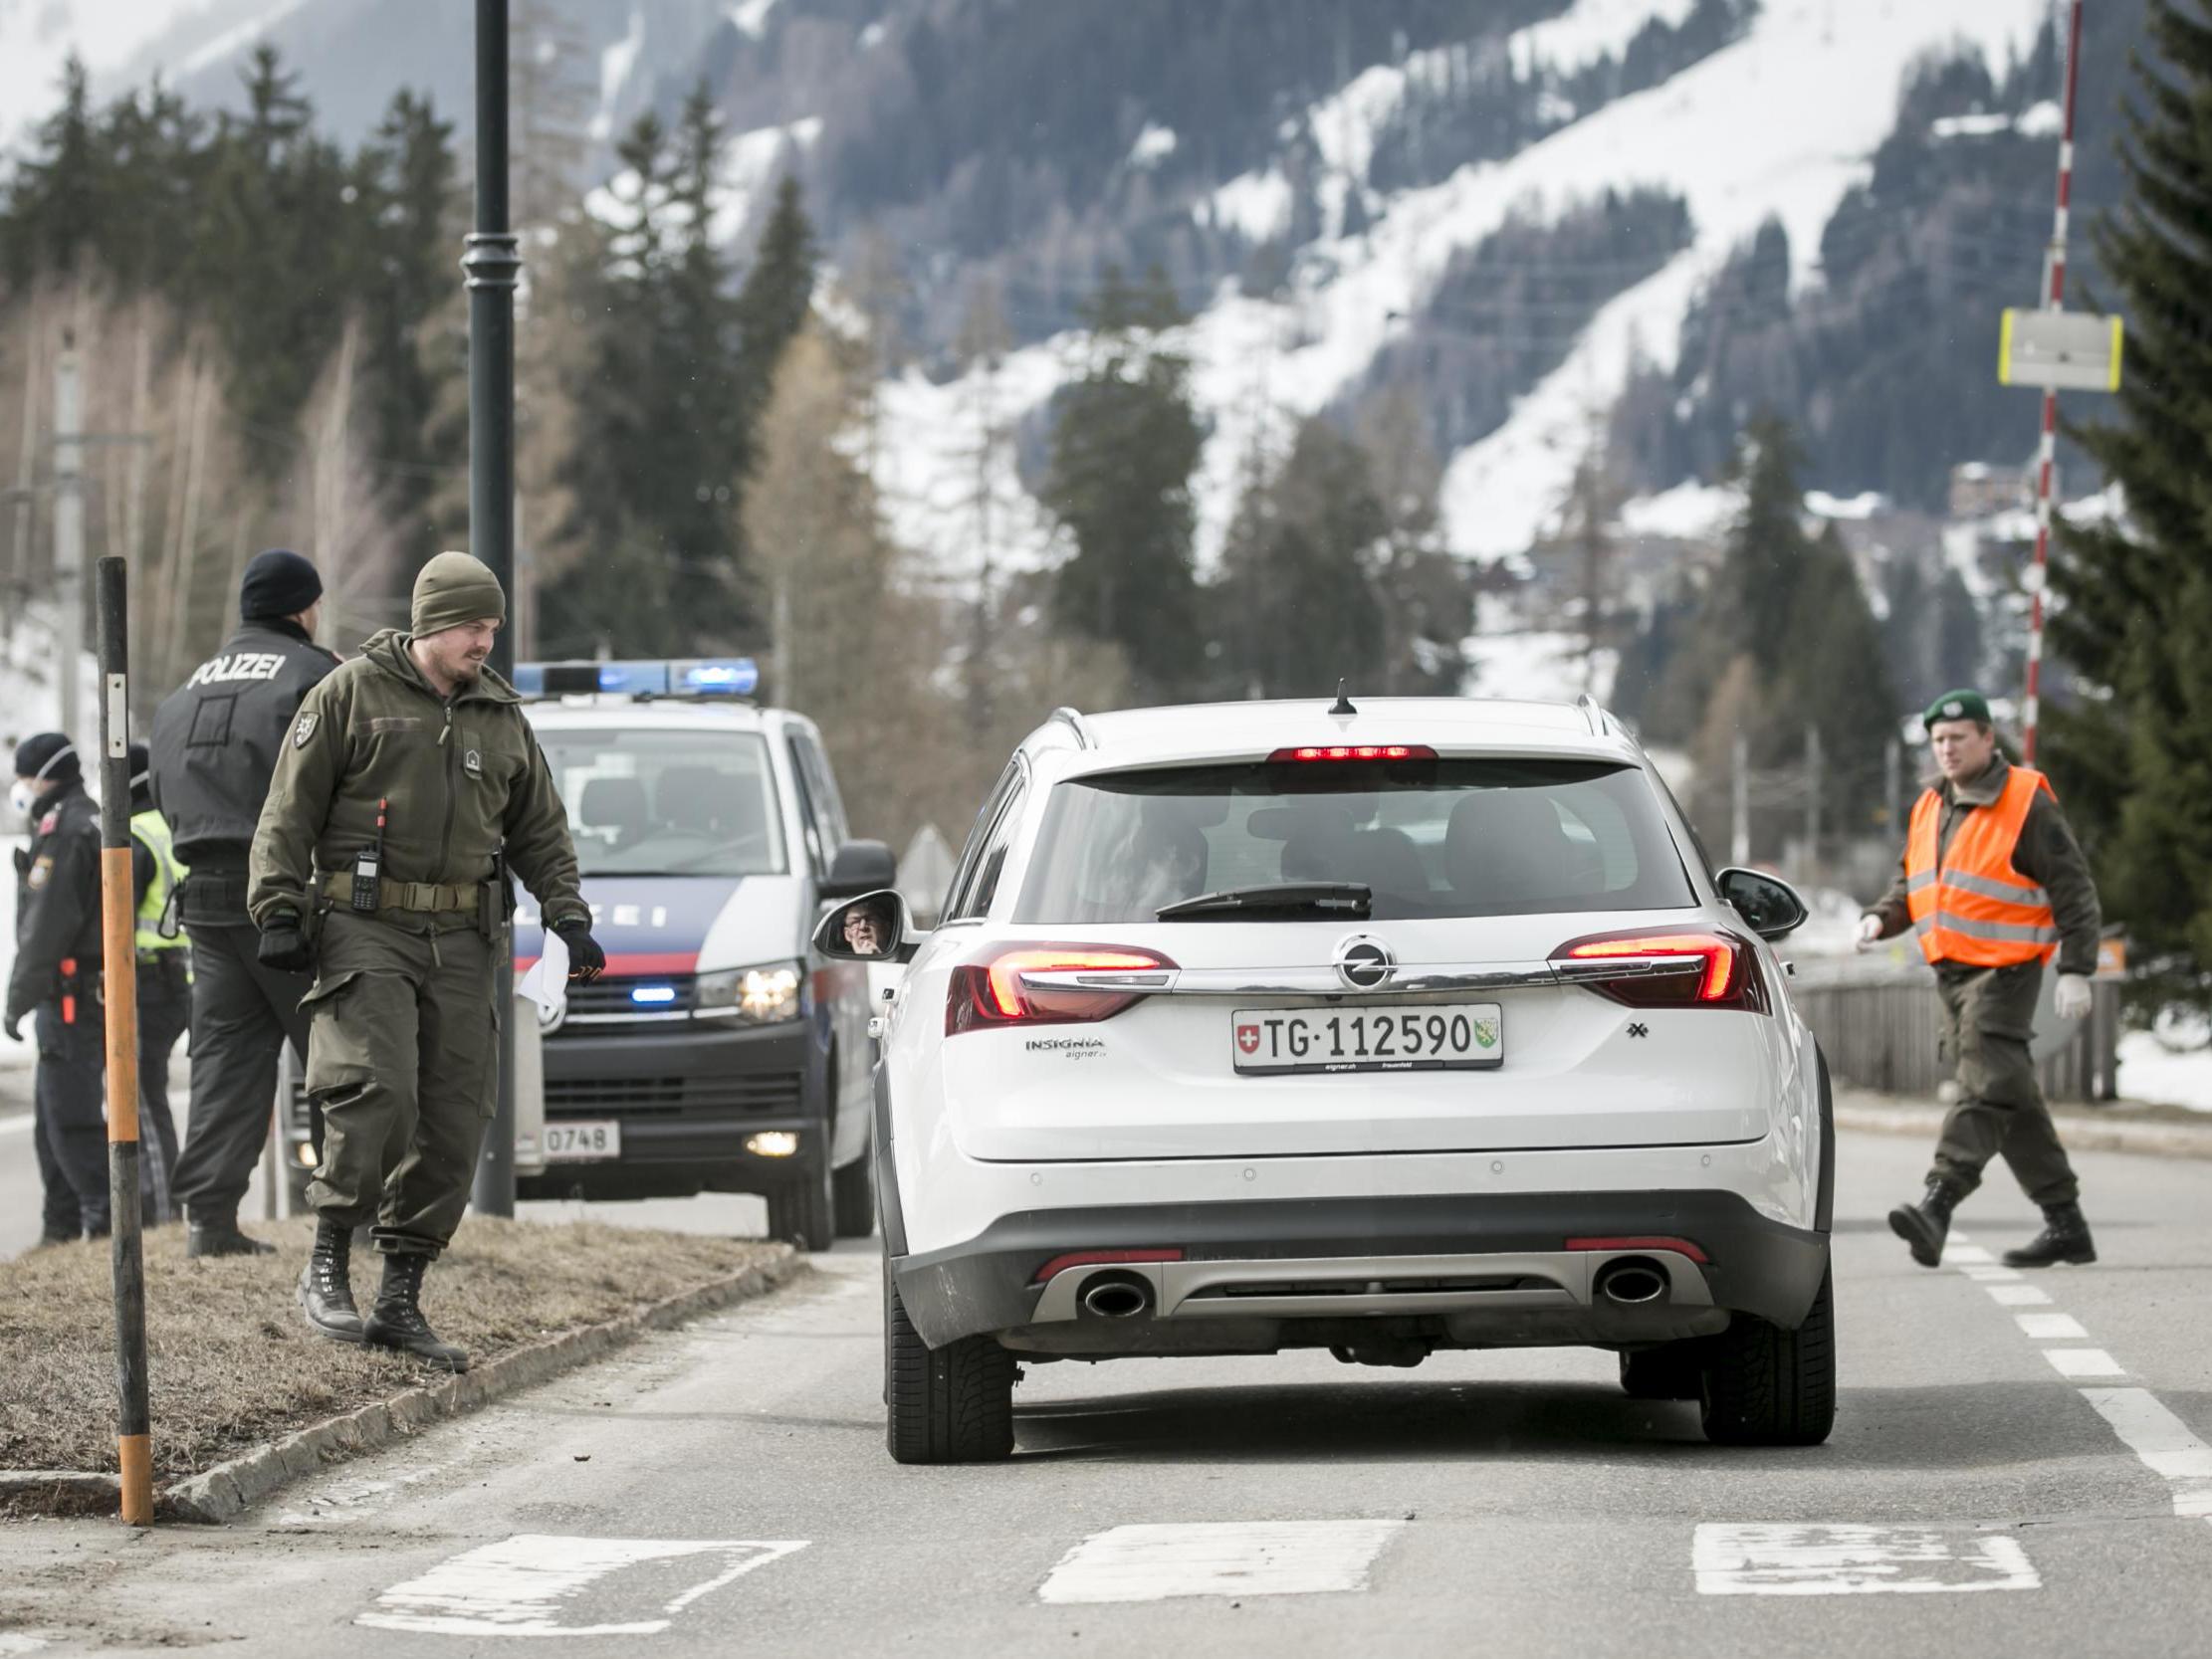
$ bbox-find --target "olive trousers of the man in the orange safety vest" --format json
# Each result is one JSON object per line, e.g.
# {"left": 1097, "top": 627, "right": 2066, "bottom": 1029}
{"left": 1933, "top": 962, "right": 2082, "bottom": 1205}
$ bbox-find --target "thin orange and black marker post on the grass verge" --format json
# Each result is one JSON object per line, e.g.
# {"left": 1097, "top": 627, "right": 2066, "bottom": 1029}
{"left": 98, "top": 557, "right": 152, "bottom": 1527}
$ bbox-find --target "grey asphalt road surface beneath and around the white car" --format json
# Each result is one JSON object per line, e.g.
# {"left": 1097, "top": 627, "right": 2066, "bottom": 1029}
{"left": 0, "top": 1135, "right": 2212, "bottom": 1659}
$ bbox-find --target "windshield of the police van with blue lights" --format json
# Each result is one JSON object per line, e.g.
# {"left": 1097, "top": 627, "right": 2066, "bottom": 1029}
{"left": 538, "top": 727, "right": 785, "bottom": 876}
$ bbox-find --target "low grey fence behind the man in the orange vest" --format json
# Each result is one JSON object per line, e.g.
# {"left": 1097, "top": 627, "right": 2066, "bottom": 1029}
{"left": 1790, "top": 960, "right": 2119, "bottom": 1104}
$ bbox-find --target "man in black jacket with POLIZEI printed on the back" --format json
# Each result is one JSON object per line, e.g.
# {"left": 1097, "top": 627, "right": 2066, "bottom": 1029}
{"left": 152, "top": 548, "right": 338, "bottom": 1256}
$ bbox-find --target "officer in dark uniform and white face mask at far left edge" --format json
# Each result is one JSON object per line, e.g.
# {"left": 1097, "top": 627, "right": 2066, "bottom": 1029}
{"left": 0, "top": 732, "right": 109, "bottom": 1245}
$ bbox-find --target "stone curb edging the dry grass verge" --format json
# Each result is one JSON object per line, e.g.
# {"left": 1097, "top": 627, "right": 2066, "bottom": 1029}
{"left": 0, "top": 1245, "right": 807, "bottom": 1527}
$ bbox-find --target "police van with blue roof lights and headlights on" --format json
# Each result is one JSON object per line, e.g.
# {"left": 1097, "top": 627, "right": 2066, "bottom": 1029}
{"left": 295, "top": 659, "right": 898, "bottom": 1250}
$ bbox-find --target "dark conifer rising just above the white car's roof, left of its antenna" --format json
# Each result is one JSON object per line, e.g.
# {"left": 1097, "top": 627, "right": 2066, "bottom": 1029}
{"left": 1042, "top": 268, "right": 1204, "bottom": 699}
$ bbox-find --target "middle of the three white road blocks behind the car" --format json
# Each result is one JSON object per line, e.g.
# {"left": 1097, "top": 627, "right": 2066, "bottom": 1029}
{"left": 1037, "top": 1520, "right": 1405, "bottom": 1601}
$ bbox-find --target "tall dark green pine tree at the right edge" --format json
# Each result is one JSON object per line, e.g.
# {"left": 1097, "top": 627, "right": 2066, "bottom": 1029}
{"left": 2040, "top": 0, "right": 2212, "bottom": 995}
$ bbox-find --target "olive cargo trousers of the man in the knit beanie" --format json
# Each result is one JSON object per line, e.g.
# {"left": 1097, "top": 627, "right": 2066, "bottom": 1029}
{"left": 301, "top": 910, "right": 500, "bottom": 1256}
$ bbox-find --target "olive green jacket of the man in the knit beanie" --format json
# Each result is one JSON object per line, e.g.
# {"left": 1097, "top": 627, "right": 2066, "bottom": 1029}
{"left": 246, "top": 628, "right": 590, "bottom": 927}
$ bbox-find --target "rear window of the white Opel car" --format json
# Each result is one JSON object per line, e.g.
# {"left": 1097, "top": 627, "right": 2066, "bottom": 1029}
{"left": 1015, "top": 761, "right": 1696, "bottom": 925}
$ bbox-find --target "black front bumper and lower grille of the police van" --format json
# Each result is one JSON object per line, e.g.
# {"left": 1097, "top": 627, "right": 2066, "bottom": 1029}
{"left": 518, "top": 1022, "right": 829, "bottom": 1199}
